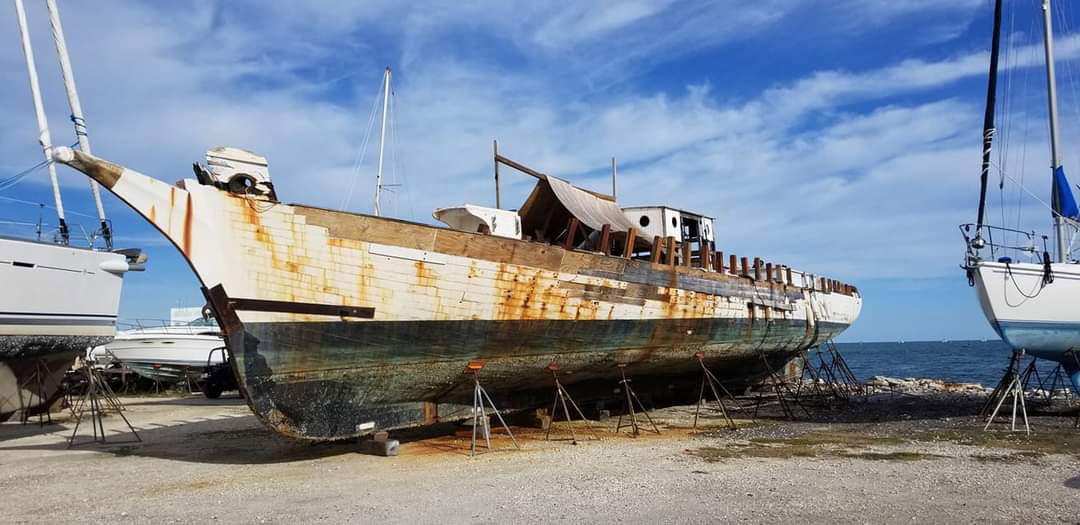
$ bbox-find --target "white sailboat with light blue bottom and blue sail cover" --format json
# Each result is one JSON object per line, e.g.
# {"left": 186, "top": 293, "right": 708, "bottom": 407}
{"left": 961, "top": 0, "right": 1080, "bottom": 388}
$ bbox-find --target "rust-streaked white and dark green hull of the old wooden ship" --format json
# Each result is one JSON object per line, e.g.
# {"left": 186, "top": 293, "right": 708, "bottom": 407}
{"left": 59, "top": 147, "right": 862, "bottom": 440}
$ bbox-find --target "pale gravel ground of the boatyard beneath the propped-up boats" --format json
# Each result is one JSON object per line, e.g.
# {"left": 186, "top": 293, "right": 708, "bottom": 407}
{"left": 0, "top": 388, "right": 1080, "bottom": 523}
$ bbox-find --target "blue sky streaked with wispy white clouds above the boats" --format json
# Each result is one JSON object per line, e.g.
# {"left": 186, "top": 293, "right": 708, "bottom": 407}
{"left": 0, "top": 0, "right": 1080, "bottom": 341}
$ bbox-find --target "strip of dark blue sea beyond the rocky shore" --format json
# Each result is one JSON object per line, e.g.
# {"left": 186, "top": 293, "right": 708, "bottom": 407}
{"left": 836, "top": 340, "right": 1057, "bottom": 387}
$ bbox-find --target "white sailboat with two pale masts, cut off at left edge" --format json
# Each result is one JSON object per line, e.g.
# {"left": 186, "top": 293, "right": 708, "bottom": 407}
{"left": 0, "top": 0, "right": 146, "bottom": 421}
